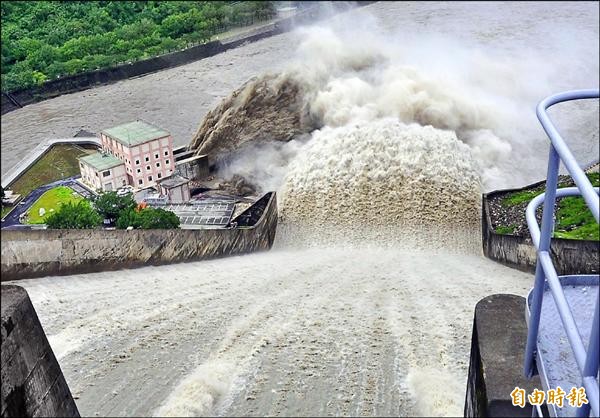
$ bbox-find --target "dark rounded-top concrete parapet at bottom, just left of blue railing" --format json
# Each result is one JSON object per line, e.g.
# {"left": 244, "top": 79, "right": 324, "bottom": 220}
{"left": 464, "top": 295, "right": 542, "bottom": 417}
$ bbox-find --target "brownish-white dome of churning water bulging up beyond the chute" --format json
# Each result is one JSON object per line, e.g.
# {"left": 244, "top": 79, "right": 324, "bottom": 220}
{"left": 279, "top": 118, "right": 481, "bottom": 253}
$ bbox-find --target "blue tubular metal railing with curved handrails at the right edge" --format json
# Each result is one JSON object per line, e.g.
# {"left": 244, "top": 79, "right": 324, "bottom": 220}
{"left": 524, "top": 90, "right": 600, "bottom": 417}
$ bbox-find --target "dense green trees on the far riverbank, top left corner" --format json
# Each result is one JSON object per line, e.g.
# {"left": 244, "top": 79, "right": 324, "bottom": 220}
{"left": 0, "top": 1, "right": 276, "bottom": 91}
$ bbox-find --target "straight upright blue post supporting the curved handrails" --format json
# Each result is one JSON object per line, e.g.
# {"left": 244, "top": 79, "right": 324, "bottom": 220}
{"left": 523, "top": 144, "right": 560, "bottom": 378}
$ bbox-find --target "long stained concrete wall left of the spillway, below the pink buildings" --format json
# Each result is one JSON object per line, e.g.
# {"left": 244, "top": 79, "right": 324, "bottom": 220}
{"left": 1, "top": 193, "right": 277, "bottom": 281}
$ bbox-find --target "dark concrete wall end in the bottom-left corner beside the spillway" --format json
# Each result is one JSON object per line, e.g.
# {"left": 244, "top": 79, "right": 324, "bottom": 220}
{"left": 1, "top": 286, "right": 79, "bottom": 417}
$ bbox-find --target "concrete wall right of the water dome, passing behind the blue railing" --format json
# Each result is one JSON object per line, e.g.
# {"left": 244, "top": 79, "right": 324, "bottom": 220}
{"left": 481, "top": 192, "right": 600, "bottom": 275}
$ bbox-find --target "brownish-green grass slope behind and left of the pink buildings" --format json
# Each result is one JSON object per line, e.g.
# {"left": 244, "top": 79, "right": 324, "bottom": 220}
{"left": 10, "top": 144, "right": 96, "bottom": 197}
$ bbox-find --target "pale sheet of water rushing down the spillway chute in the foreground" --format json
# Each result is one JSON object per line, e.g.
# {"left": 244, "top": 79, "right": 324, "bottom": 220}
{"left": 12, "top": 247, "right": 532, "bottom": 416}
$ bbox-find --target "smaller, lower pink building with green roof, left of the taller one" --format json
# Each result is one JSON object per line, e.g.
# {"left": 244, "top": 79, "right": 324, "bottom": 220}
{"left": 79, "top": 152, "right": 129, "bottom": 192}
